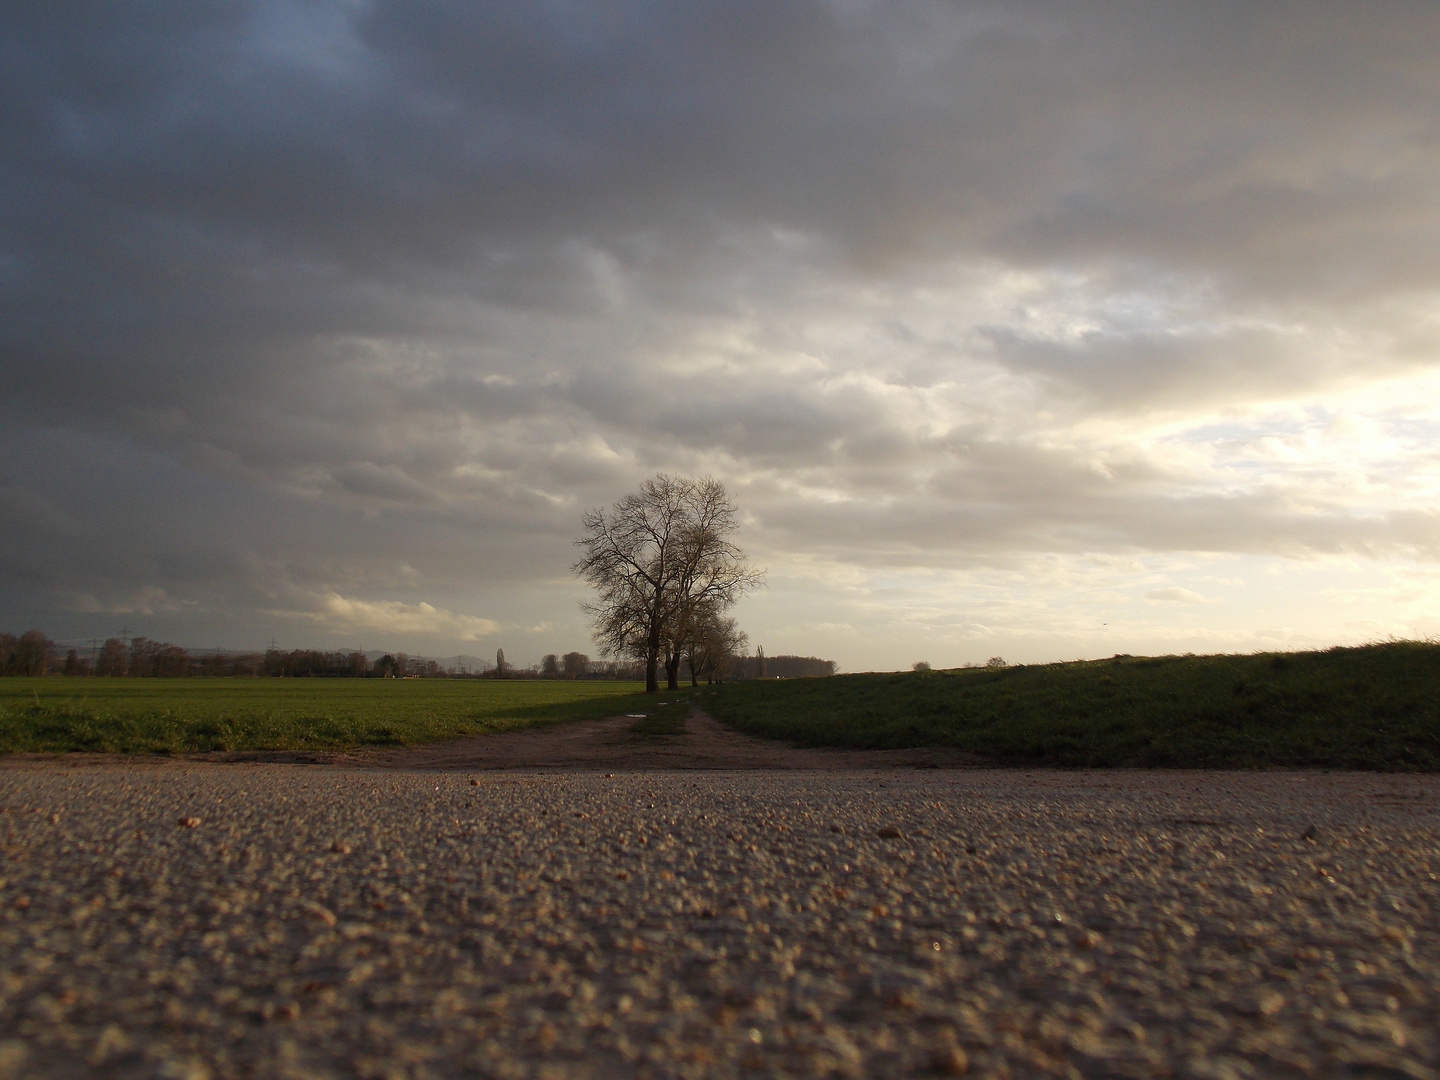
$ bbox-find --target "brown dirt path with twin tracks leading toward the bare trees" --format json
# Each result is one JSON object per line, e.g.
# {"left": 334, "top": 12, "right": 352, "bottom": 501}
{"left": 360, "top": 708, "right": 986, "bottom": 772}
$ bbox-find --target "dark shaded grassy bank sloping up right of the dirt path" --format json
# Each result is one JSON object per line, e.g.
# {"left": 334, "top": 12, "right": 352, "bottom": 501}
{"left": 700, "top": 642, "right": 1440, "bottom": 772}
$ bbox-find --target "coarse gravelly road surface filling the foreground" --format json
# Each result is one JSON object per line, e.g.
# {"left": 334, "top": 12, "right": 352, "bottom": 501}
{"left": 0, "top": 763, "right": 1440, "bottom": 1080}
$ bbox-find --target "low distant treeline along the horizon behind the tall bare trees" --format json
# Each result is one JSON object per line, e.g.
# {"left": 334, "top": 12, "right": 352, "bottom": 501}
{"left": 0, "top": 629, "right": 835, "bottom": 680}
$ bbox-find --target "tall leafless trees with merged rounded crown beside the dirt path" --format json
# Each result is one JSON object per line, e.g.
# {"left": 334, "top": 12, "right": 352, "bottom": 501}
{"left": 572, "top": 474, "right": 763, "bottom": 694}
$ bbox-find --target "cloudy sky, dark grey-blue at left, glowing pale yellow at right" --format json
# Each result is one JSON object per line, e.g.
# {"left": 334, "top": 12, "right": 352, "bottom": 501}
{"left": 0, "top": 0, "right": 1440, "bottom": 671}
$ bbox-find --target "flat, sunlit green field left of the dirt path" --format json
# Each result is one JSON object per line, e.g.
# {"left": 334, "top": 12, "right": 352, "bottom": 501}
{"left": 0, "top": 677, "right": 654, "bottom": 753}
